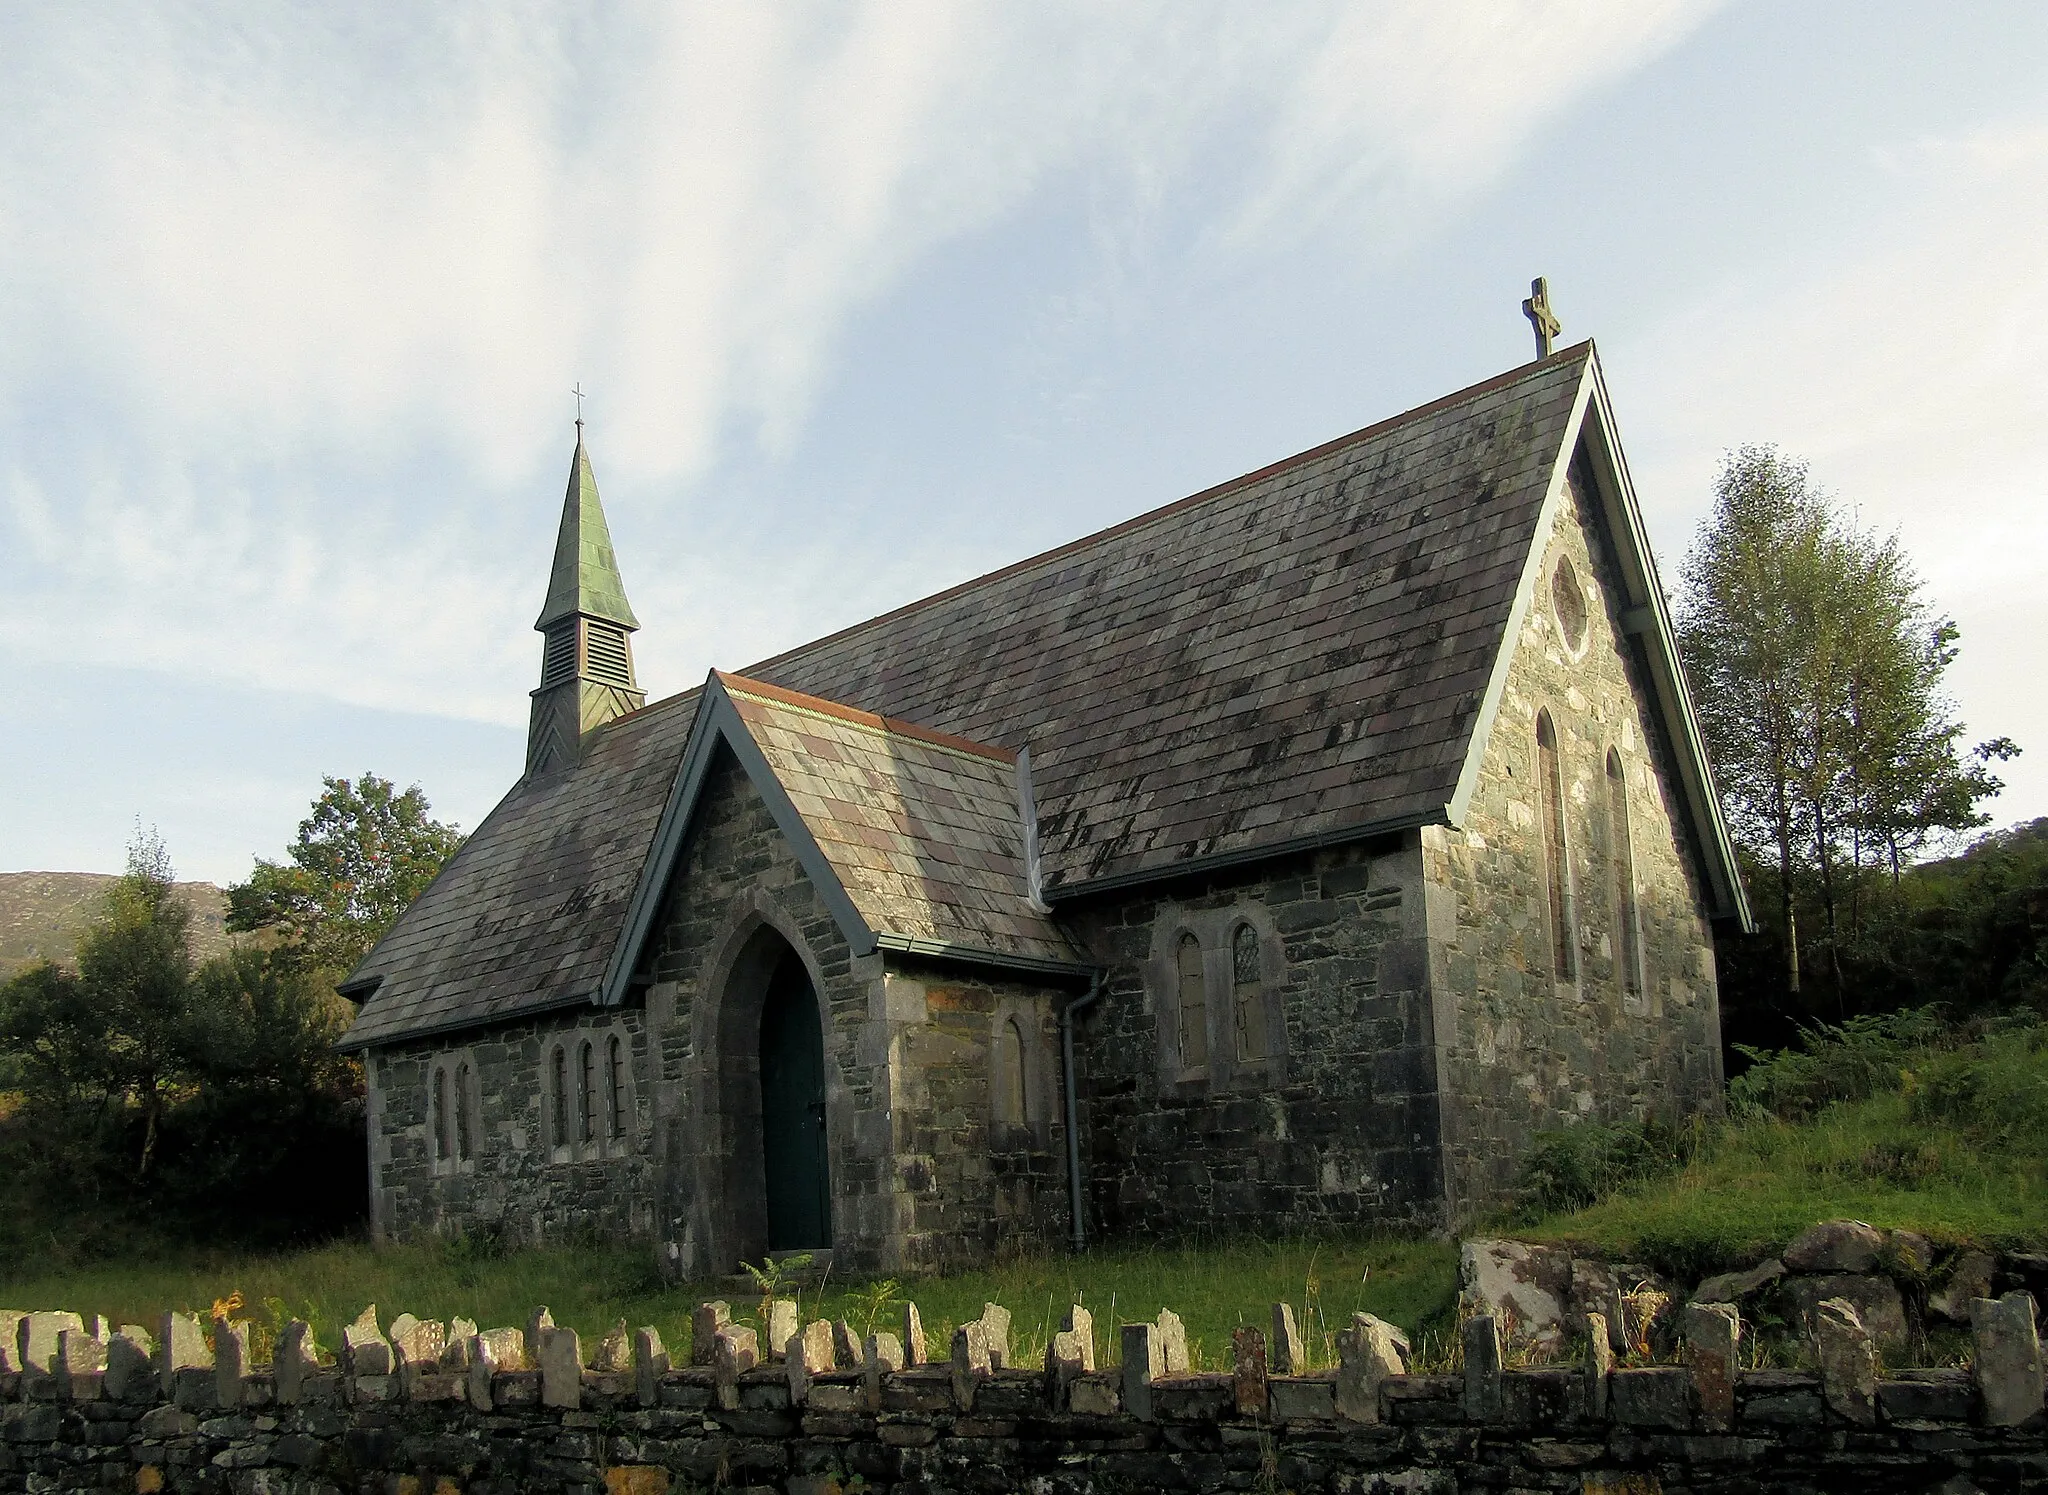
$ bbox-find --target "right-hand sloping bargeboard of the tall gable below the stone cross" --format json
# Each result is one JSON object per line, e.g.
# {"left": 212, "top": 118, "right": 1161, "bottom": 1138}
{"left": 1591, "top": 354, "right": 1755, "bottom": 934}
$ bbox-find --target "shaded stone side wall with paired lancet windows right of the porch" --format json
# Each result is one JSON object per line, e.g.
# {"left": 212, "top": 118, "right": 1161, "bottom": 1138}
{"left": 1061, "top": 836, "right": 1442, "bottom": 1237}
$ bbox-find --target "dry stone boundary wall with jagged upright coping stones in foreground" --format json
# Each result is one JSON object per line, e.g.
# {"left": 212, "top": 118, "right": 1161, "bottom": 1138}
{"left": 0, "top": 1292, "right": 2048, "bottom": 1495}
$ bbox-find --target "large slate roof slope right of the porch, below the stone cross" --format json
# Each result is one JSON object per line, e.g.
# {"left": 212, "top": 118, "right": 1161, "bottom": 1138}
{"left": 745, "top": 344, "right": 1591, "bottom": 891}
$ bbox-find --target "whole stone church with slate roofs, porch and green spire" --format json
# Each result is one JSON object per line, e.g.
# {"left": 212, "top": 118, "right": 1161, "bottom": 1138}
{"left": 344, "top": 344, "right": 1747, "bottom": 1276}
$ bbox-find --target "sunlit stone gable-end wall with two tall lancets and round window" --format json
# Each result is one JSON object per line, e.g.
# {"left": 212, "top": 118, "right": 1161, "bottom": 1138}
{"left": 1423, "top": 462, "right": 1722, "bottom": 1219}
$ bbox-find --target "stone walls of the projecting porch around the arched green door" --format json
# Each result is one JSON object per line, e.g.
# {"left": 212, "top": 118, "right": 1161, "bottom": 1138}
{"left": 643, "top": 758, "right": 1065, "bottom": 1276}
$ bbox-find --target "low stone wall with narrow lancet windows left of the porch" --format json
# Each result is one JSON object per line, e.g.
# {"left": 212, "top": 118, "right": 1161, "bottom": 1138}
{"left": 367, "top": 1010, "right": 653, "bottom": 1245}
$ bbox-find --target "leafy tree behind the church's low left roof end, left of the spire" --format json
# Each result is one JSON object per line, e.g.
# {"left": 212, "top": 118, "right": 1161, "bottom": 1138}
{"left": 227, "top": 774, "right": 463, "bottom": 977}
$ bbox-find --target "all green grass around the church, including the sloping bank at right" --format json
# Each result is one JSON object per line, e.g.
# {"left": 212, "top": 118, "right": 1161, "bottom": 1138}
{"left": 0, "top": 1014, "right": 2048, "bottom": 1368}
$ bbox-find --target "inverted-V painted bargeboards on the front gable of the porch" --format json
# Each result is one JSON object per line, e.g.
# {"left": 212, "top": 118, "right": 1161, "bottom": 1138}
{"left": 596, "top": 670, "right": 874, "bottom": 1008}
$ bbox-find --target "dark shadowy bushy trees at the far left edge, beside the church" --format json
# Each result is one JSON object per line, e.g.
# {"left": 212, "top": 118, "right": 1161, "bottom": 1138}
{"left": 0, "top": 834, "right": 365, "bottom": 1249}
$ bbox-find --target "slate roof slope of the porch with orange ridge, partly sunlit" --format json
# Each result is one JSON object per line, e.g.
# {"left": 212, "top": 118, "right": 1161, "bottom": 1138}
{"left": 719, "top": 676, "right": 1081, "bottom": 963}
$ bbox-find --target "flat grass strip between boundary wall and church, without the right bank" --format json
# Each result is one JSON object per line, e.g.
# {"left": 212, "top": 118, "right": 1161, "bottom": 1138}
{"left": 0, "top": 1237, "right": 1458, "bottom": 1370}
